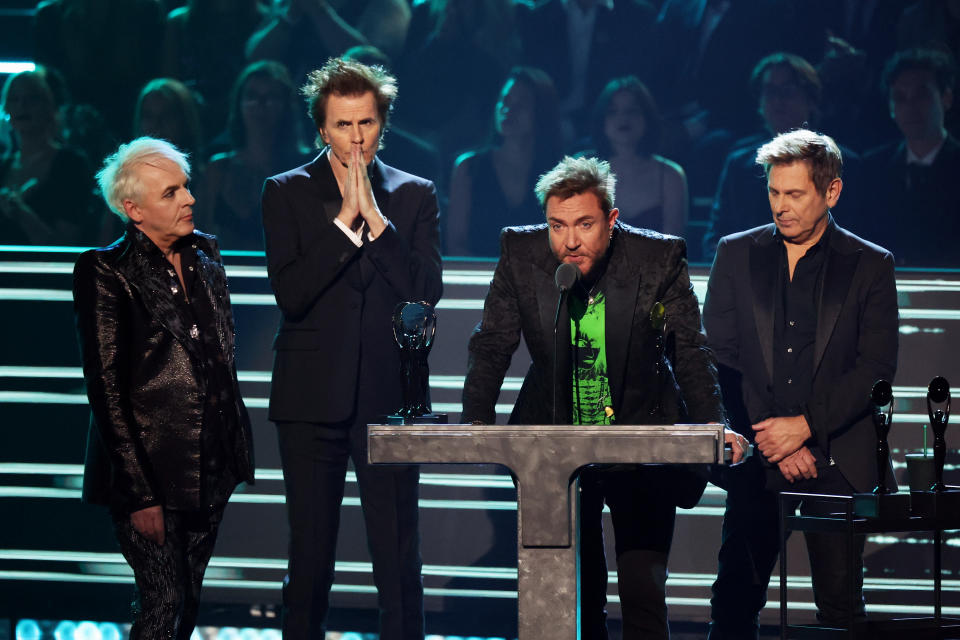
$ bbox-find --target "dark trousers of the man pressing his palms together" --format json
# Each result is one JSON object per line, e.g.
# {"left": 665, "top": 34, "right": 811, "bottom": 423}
{"left": 277, "top": 422, "right": 423, "bottom": 640}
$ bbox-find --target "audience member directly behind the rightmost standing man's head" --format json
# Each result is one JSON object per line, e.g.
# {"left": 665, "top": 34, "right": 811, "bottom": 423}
{"left": 703, "top": 52, "right": 858, "bottom": 262}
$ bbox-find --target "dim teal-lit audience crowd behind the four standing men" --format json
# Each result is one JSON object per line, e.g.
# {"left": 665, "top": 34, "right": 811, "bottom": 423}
{"left": 0, "top": 0, "right": 960, "bottom": 267}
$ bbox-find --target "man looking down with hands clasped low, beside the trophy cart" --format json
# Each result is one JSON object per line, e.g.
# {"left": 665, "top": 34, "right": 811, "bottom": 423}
{"left": 704, "top": 130, "right": 898, "bottom": 639}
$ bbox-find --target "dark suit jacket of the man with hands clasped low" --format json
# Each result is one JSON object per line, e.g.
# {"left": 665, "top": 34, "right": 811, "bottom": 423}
{"left": 703, "top": 218, "right": 899, "bottom": 491}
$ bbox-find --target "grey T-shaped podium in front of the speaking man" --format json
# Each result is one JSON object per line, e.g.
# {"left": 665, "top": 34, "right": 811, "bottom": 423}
{"left": 368, "top": 424, "right": 724, "bottom": 640}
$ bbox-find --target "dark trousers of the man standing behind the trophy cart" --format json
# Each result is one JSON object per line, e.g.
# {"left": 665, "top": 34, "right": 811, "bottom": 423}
{"left": 709, "top": 458, "right": 866, "bottom": 640}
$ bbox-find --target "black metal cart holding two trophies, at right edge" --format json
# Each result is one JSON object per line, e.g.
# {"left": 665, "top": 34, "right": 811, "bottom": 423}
{"left": 780, "top": 377, "right": 960, "bottom": 640}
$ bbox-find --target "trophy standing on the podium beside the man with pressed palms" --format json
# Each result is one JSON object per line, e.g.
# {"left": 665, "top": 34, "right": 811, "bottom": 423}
{"left": 393, "top": 302, "right": 437, "bottom": 420}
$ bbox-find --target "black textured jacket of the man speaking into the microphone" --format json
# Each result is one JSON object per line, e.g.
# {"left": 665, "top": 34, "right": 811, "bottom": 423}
{"left": 461, "top": 223, "right": 723, "bottom": 506}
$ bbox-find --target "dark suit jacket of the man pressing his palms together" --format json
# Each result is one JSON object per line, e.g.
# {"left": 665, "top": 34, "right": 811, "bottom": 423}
{"left": 263, "top": 153, "right": 443, "bottom": 422}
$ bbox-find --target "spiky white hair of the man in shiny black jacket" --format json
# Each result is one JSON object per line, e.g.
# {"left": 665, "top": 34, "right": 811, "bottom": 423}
{"left": 97, "top": 136, "right": 190, "bottom": 221}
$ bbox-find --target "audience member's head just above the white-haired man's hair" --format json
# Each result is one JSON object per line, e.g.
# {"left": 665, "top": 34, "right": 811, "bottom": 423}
{"left": 133, "top": 78, "right": 203, "bottom": 166}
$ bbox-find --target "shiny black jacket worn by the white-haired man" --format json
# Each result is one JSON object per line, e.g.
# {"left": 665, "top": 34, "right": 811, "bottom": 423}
{"left": 73, "top": 227, "right": 254, "bottom": 512}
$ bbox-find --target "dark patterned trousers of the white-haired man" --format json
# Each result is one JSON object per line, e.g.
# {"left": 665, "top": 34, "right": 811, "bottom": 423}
{"left": 112, "top": 507, "right": 223, "bottom": 640}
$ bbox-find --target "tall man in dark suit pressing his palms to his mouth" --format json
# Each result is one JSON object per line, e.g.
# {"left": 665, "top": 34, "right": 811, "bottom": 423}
{"left": 263, "top": 59, "right": 442, "bottom": 640}
